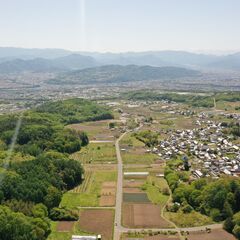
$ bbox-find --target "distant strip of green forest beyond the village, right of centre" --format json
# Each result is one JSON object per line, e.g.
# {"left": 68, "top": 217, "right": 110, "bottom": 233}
{"left": 123, "top": 91, "right": 240, "bottom": 108}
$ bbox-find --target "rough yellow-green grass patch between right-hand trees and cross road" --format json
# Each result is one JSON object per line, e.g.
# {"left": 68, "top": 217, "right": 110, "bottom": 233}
{"left": 165, "top": 211, "right": 213, "bottom": 227}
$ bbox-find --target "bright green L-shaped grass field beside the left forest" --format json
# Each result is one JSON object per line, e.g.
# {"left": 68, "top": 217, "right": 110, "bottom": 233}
{"left": 60, "top": 171, "right": 117, "bottom": 209}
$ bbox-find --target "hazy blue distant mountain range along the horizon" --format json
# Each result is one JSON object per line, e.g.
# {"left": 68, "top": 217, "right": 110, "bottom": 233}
{"left": 0, "top": 48, "right": 240, "bottom": 73}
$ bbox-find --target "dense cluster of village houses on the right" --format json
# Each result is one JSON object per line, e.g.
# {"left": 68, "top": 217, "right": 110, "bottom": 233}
{"left": 153, "top": 115, "right": 240, "bottom": 178}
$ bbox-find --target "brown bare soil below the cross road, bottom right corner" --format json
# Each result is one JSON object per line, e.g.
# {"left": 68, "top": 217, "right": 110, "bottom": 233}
{"left": 187, "top": 229, "right": 236, "bottom": 240}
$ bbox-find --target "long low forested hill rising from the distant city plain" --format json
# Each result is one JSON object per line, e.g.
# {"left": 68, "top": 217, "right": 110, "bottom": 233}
{"left": 48, "top": 65, "right": 200, "bottom": 84}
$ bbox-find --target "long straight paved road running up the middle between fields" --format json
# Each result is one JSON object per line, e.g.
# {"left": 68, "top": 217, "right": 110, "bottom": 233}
{"left": 114, "top": 132, "right": 127, "bottom": 240}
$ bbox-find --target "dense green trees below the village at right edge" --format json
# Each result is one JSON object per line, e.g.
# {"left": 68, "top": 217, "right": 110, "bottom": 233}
{"left": 165, "top": 160, "right": 240, "bottom": 239}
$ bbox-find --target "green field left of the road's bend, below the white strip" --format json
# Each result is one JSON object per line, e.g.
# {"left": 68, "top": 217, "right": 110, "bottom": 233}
{"left": 71, "top": 143, "right": 117, "bottom": 163}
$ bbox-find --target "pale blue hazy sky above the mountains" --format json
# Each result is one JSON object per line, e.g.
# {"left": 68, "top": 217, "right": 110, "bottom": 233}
{"left": 0, "top": 0, "right": 240, "bottom": 52}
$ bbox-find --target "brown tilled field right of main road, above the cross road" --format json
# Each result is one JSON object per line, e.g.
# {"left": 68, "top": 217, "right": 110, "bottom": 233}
{"left": 123, "top": 204, "right": 169, "bottom": 228}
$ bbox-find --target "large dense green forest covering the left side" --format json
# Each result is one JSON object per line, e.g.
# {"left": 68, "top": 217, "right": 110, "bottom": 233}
{"left": 0, "top": 99, "right": 112, "bottom": 240}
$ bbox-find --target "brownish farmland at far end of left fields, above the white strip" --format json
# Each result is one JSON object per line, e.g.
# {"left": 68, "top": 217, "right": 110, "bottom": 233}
{"left": 68, "top": 120, "right": 119, "bottom": 141}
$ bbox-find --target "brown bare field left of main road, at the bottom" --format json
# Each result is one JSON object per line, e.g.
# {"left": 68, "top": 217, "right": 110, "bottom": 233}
{"left": 79, "top": 209, "right": 114, "bottom": 240}
